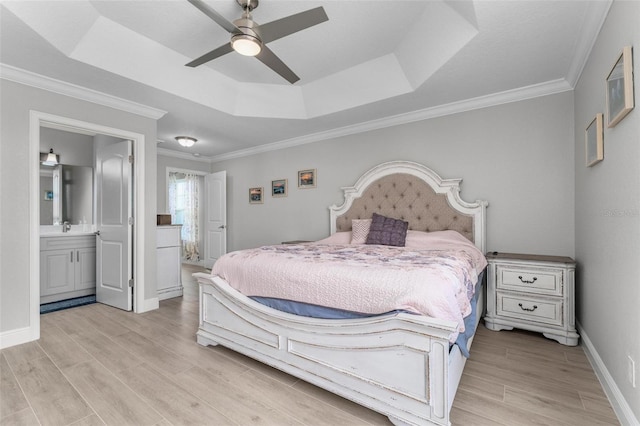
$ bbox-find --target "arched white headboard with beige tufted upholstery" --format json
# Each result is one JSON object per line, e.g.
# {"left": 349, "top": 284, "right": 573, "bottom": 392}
{"left": 330, "top": 161, "right": 487, "bottom": 252}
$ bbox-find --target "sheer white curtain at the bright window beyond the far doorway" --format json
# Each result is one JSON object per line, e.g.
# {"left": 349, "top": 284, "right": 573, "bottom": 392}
{"left": 169, "top": 172, "right": 200, "bottom": 262}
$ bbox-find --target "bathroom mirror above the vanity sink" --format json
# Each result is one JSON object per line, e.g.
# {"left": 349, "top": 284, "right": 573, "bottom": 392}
{"left": 40, "top": 164, "right": 93, "bottom": 225}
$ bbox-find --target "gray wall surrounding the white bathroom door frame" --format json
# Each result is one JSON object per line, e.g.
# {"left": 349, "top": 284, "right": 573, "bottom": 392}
{"left": 0, "top": 79, "right": 157, "bottom": 333}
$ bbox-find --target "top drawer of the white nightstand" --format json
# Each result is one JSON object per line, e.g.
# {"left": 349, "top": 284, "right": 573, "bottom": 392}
{"left": 496, "top": 265, "right": 562, "bottom": 296}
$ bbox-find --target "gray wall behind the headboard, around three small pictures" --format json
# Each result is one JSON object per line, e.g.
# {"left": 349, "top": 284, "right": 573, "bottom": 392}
{"left": 212, "top": 92, "right": 574, "bottom": 256}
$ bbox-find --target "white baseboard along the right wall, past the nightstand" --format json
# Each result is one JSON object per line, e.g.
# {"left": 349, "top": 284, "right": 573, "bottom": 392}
{"left": 576, "top": 322, "right": 640, "bottom": 426}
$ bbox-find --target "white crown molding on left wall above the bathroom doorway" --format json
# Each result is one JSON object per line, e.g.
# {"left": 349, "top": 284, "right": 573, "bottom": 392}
{"left": 0, "top": 63, "right": 167, "bottom": 120}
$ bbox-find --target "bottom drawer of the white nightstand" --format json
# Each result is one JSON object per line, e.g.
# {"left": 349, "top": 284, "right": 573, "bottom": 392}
{"left": 497, "top": 292, "right": 563, "bottom": 326}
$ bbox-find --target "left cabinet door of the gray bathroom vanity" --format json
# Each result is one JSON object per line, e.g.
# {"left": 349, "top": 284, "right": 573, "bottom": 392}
{"left": 40, "top": 249, "right": 75, "bottom": 296}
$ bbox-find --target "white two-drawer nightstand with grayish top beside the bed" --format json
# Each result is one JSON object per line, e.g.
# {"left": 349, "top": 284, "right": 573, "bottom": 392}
{"left": 484, "top": 252, "right": 580, "bottom": 346}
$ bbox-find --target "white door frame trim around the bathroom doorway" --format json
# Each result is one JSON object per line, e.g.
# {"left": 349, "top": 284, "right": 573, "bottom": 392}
{"left": 29, "top": 110, "right": 149, "bottom": 340}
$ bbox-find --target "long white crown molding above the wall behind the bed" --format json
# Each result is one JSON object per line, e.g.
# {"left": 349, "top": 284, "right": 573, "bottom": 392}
{"left": 209, "top": 79, "right": 573, "bottom": 163}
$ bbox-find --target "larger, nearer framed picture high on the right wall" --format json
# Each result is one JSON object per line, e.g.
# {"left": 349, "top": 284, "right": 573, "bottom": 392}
{"left": 607, "top": 46, "right": 634, "bottom": 127}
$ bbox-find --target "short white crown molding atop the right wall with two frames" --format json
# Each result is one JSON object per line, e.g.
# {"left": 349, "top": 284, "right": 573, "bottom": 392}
{"left": 567, "top": 0, "right": 613, "bottom": 87}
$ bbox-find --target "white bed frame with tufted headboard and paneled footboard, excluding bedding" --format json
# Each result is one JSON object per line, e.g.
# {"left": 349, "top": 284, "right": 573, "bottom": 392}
{"left": 195, "top": 161, "right": 487, "bottom": 425}
